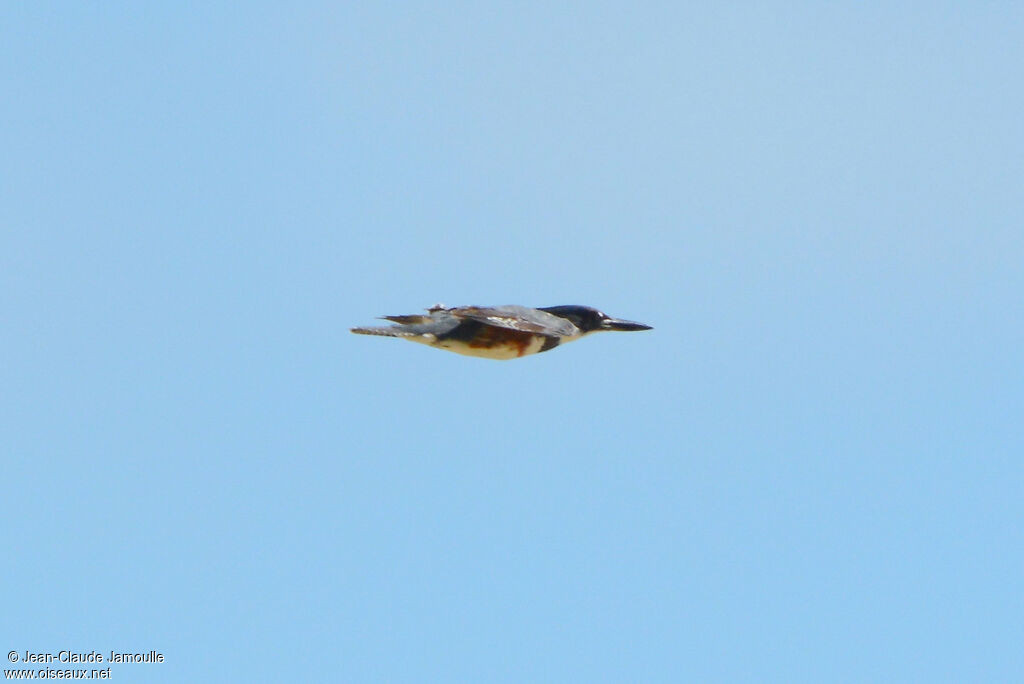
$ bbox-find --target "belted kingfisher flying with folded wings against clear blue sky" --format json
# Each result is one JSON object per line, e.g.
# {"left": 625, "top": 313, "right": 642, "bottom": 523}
{"left": 352, "top": 304, "right": 651, "bottom": 359}
